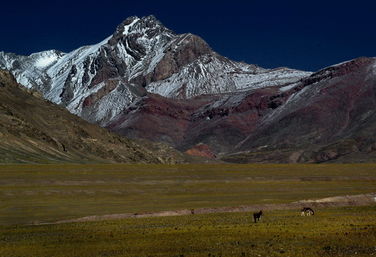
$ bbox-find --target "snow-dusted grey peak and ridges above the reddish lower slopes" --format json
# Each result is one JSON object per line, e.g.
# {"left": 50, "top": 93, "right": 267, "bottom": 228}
{"left": 0, "top": 16, "right": 311, "bottom": 126}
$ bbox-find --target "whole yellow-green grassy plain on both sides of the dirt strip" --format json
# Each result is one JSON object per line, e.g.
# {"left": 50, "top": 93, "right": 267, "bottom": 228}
{"left": 0, "top": 164, "right": 376, "bottom": 257}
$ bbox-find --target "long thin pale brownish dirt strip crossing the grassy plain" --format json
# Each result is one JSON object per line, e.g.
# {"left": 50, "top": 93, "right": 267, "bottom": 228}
{"left": 41, "top": 193, "right": 376, "bottom": 225}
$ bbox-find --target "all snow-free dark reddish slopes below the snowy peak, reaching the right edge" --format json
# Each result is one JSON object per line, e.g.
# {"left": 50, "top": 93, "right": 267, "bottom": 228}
{"left": 108, "top": 58, "right": 376, "bottom": 162}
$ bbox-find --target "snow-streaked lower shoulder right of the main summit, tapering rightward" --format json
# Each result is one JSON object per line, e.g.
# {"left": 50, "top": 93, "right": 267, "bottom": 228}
{"left": 146, "top": 55, "right": 310, "bottom": 98}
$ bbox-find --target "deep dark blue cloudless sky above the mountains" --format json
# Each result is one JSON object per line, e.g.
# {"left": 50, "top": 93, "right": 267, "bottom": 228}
{"left": 0, "top": 0, "right": 376, "bottom": 70}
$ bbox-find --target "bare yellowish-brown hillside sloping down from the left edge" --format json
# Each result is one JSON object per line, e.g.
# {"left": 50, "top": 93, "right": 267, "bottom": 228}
{"left": 0, "top": 70, "right": 181, "bottom": 163}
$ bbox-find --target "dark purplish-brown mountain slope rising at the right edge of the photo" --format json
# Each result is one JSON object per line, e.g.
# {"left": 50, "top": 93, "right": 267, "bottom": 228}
{"left": 226, "top": 58, "right": 376, "bottom": 162}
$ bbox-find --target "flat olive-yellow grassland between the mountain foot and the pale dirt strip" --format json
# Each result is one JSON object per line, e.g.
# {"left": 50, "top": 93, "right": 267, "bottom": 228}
{"left": 0, "top": 164, "right": 376, "bottom": 225}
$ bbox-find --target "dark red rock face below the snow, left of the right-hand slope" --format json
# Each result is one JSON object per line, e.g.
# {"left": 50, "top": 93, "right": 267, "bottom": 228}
{"left": 104, "top": 88, "right": 288, "bottom": 155}
